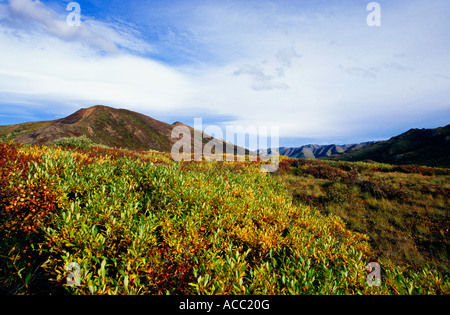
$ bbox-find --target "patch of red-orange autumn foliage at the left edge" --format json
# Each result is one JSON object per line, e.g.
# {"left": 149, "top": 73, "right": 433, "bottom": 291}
{"left": 0, "top": 143, "right": 58, "bottom": 291}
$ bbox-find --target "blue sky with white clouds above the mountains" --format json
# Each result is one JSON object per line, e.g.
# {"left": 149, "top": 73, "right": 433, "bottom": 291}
{"left": 0, "top": 0, "right": 450, "bottom": 147}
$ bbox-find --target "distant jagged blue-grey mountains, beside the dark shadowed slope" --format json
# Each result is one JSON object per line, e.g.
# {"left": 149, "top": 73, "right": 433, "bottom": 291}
{"left": 268, "top": 142, "right": 375, "bottom": 159}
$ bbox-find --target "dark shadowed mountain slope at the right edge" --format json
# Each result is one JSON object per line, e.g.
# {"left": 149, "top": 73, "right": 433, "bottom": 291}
{"left": 329, "top": 125, "right": 450, "bottom": 168}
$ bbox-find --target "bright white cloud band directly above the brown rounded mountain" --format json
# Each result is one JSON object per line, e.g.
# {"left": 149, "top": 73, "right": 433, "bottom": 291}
{"left": 0, "top": 26, "right": 191, "bottom": 116}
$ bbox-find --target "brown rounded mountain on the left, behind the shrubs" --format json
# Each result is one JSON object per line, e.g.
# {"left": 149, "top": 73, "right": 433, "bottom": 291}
{"left": 0, "top": 105, "right": 248, "bottom": 153}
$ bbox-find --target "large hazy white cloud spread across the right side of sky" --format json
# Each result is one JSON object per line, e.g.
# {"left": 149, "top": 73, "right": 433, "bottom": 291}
{"left": 177, "top": 1, "right": 450, "bottom": 140}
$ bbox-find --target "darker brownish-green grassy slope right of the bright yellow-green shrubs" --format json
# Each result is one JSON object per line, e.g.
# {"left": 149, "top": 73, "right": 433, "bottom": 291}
{"left": 281, "top": 160, "right": 450, "bottom": 273}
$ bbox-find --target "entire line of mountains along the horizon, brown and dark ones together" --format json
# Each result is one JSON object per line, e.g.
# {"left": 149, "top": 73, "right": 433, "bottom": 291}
{"left": 0, "top": 105, "right": 450, "bottom": 168}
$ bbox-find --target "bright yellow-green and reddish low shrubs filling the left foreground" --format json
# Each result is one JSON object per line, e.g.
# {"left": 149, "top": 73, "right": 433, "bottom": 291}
{"left": 0, "top": 143, "right": 450, "bottom": 294}
